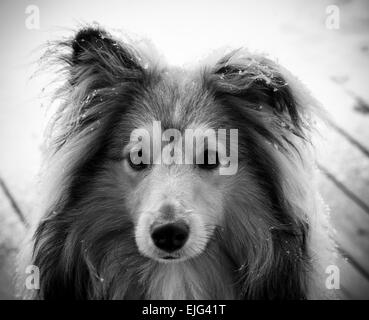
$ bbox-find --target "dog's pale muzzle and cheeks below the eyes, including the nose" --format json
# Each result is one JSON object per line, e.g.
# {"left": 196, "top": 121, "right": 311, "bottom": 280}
{"left": 123, "top": 131, "right": 225, "bottom": 262}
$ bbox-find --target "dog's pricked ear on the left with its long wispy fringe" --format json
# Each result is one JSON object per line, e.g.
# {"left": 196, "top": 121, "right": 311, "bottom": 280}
{"left": 44, "top": 27, "right": 145, "bottom": 151}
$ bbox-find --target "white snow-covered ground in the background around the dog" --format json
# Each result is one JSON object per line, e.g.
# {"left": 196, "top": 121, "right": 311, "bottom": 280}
{"left": 0, "top": 0, "right": 369, "bottom": 298}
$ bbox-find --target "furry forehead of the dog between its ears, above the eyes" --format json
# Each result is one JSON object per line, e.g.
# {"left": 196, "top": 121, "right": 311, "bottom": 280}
{"left": 133, "top": 72, "right": 220, "bottom": 131}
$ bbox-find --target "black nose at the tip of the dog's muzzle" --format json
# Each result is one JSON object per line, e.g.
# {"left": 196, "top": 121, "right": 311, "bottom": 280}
{"left": 151, "top": 222, "right": 189, "bottom": 252}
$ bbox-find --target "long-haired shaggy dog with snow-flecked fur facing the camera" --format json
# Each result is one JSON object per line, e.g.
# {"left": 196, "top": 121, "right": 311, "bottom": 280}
{"left": 18, "top": 26, "right": 336, "bottom": 300}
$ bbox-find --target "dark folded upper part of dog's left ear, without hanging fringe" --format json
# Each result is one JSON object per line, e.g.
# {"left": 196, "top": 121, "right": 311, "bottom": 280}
{"left": 69, "top": 28, "right": 143, "bottom": 89}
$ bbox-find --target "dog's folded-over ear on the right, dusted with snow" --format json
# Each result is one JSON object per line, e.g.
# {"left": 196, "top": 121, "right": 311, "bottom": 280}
{"left": 207, "top": 51, "right": 313, "bottom": 139}
